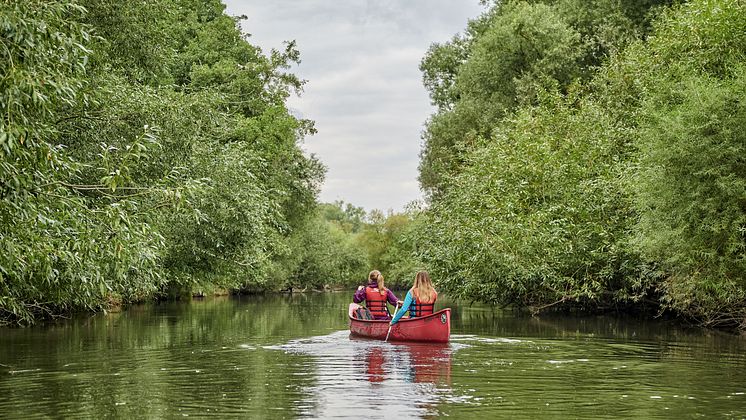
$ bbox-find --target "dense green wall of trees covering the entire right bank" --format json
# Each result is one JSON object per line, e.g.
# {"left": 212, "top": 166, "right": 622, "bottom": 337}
{"left": 413, "top": 0, "right": 746, "bottom": 328}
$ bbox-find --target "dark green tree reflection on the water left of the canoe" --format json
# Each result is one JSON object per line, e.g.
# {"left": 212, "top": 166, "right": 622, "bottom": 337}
{"left": 0, "top": 295, "right": 316, "bottom": 418}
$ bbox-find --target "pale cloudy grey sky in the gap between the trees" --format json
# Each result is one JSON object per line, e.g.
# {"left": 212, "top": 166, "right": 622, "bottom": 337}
{"left": 223, "top": 0, "right": 484, "bottom": 212}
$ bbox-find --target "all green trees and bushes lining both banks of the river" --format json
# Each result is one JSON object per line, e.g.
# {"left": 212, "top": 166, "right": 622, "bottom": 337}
{"left": 0, "top": 0, "right": 746, "bottom": 332}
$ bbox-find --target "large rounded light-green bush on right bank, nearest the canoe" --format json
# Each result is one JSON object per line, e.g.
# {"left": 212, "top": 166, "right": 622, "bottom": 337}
{"left": 418, "top": 93, "right": 645, "bottom": 308}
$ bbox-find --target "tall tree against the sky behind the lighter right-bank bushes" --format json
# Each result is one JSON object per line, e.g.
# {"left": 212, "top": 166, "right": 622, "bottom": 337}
{"left": 419, "top": 0, "right": 667, "bottom": 199}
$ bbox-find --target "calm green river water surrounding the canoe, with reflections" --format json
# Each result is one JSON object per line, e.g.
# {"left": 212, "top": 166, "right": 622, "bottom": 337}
{"left": 0, "top": 292, "right": 746, "bottom": 419}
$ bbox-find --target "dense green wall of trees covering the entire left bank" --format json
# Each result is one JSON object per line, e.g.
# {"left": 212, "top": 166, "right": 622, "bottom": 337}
{"left": 0, "top": 0, "right": 323, "bottom": 323}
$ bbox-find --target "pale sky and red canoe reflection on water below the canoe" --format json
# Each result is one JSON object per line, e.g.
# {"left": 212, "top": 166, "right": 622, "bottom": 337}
{"left": 271, "top": 331, "right": 465, "bottom": 418}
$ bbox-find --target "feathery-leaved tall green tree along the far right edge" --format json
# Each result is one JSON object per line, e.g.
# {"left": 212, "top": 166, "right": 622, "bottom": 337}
{"left": 615, "top": 0, "right": 746, "bottom": 328}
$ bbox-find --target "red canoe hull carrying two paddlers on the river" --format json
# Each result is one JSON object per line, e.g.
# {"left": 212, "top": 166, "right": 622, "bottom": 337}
{"left": 348, "top": 308, "right": 451, "bottom": 343}
